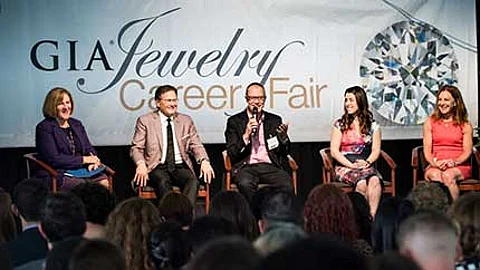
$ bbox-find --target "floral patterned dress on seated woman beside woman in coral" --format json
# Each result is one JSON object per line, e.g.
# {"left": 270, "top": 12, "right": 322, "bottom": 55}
{"left": 334, "top": 119, "right": 383, "bottom": 186}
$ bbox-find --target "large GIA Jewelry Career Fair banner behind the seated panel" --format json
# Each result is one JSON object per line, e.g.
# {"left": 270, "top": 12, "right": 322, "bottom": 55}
{"left": 0, "top": 0, "right": 478, "bottom": 147}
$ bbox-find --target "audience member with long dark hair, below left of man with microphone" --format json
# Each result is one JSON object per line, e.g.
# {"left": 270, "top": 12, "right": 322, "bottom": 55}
{"left": 209, "top": 191, "right": 258, "bottom": 241}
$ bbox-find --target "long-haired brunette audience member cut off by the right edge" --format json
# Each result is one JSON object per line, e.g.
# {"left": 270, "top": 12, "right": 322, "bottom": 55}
{"left": 450, "top": 192, "right": 480, "bottom": 270}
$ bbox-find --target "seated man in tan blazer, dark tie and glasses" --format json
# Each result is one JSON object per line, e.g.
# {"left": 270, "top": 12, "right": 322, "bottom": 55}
{"left": 130, "top": 85, "right": 214, "bottom": 205}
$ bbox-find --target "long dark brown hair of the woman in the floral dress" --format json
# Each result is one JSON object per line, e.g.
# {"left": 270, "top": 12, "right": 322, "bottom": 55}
{"left": 340, "top": 86, "right": 373, "bottom": 135}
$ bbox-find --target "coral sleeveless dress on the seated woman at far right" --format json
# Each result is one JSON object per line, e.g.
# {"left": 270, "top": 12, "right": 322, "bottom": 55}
{"left": 430, "top": 118, "right": 472, "bottom": 179}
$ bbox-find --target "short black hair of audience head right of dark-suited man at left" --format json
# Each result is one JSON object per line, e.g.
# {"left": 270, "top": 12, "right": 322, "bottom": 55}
{"left": 41, "top": 192, "right": 86, "bottom": 242}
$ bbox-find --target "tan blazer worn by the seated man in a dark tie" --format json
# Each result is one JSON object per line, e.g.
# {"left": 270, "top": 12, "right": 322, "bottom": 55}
{"left": 130, "top": 111, "right": 210, "bottom": 172}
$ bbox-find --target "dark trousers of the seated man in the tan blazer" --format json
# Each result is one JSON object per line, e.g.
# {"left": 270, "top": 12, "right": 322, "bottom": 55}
{"left": 148, "top": 163, "right": 198, "bottom": 206}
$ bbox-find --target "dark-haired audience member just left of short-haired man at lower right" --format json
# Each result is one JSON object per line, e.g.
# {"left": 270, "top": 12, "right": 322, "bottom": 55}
{"left": 372, "top": 197, "right": 414, "bottom": 254}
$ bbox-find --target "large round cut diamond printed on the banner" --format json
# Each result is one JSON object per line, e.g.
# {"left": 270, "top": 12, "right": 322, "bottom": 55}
{"left": 360, "top": 21, "right": 458, "bottom": 125}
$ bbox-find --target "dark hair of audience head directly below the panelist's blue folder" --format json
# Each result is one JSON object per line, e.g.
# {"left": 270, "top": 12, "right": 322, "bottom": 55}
{"left": 71, "top": 182, "right": 115, "bottom": 225}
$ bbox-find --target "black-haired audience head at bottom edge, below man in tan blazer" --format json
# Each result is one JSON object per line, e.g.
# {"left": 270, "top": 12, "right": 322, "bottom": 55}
{"left": 148, "top": 221, "right": 191, "bottom": 270}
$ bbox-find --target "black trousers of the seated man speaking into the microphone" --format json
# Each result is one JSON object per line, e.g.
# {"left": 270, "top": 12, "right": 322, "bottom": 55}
{"left": 233, "top": 163, "right": 293, "bottom": 203}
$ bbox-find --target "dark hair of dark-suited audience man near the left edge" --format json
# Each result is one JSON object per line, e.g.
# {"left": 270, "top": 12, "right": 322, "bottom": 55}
{"left": 12, "top": 178, "right": 49, "bottom": 221}
